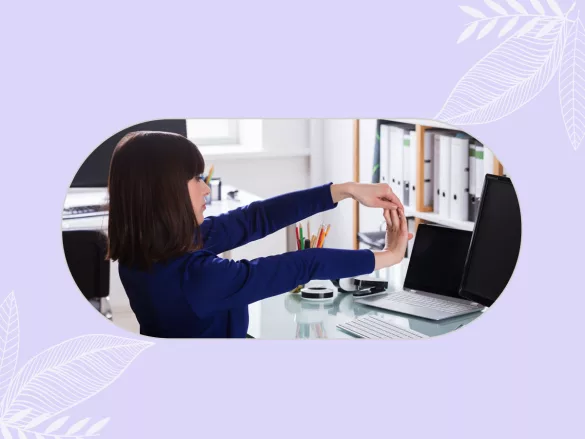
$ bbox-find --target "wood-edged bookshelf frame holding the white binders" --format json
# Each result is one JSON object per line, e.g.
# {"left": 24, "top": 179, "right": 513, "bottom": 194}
{"left": 353, "top": 119, "right": 504, "bottom": 249}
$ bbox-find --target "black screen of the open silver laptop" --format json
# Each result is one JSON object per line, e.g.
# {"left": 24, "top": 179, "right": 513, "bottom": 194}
{"left": 404, "top": 224, "right": 471, "bottom": 298}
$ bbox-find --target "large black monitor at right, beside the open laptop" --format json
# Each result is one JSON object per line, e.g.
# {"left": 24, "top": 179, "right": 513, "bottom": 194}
{"left": 459, "top": 174, "right": 522, "bottom": 306}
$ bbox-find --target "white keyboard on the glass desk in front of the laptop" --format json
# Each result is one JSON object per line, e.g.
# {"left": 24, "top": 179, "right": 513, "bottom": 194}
{"left": 337, "top": 315, "right": 428, "bottom": 340}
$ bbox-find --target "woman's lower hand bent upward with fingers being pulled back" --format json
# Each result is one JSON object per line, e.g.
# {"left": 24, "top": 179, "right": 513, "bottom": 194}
{"left": 374, "top": 209, "right": 413, "bottom": 270}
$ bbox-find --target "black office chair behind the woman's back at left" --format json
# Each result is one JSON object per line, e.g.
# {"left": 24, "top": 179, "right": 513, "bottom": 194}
{"left": 63, "top": 230, "right": 112, "bottom": 320}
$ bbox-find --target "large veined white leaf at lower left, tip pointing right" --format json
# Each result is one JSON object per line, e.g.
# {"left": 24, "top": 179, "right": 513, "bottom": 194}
{"left": 4, "top": 334, "right": 153, "bottom": 425}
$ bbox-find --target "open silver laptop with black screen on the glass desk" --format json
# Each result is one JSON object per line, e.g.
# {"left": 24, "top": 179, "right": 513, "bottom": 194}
{"left": 355, "top": 224, "right": 484, "bottom": 320}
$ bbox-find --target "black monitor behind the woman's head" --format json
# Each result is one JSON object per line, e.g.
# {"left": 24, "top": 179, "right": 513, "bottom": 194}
{"left": 71, "top": 119, "right": 187, "bottom": 188}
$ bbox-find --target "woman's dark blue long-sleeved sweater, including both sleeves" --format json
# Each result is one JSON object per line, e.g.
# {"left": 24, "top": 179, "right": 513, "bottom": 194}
{"left": 119, "top": 184, "right": 374, "bottom": 338}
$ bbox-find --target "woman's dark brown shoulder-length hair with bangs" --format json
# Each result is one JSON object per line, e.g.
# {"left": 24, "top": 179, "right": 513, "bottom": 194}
{"left": 108, "top": 131, "right": 205, "bottom": 270}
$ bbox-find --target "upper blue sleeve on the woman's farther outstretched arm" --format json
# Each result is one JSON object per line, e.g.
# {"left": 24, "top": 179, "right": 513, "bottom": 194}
{"left": 202, "top": 183, "right": 337, "bottom": 254}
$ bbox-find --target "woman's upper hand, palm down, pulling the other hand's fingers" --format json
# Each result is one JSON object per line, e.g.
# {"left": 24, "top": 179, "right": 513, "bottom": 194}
{"left": 331, "top": 183, "right": 404, "bottom": 210}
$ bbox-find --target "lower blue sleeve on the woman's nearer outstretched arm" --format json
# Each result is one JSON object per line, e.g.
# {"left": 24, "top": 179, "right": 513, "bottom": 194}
{"left": 183, "top": 248, "right": 375, "bottom": 316}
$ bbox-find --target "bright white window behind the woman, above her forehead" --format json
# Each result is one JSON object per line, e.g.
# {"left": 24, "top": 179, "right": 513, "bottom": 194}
{"left": 187, "top": 119, "right": 240, "bottom": 146}
